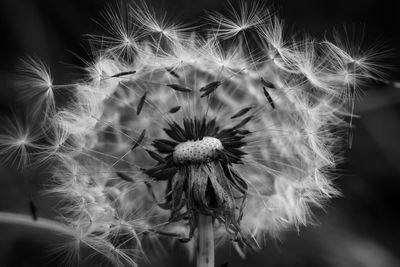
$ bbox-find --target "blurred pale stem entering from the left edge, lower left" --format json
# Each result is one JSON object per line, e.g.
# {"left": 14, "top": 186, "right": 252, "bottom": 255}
{"left": 0, "top": 212, "right": 74, "bottom": 236}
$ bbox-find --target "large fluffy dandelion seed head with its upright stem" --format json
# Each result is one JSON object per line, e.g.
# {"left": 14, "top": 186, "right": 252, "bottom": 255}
{"left": 0, "top": 4, "right": 388, "bottom": 267}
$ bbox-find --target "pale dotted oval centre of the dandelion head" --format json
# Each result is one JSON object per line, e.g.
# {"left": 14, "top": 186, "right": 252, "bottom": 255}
{"left": 173, "top": 136, "right": 224, "bottom": 163}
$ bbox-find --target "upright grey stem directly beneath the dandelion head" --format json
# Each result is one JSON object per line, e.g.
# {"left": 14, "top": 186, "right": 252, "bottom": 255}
{"left": 196, "top": 214, "right": 214, "bottom": 267}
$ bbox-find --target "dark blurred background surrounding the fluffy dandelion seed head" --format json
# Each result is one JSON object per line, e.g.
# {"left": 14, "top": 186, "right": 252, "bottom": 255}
{"left": 0, "top": 0, "right": 400, "bottom": 267}
